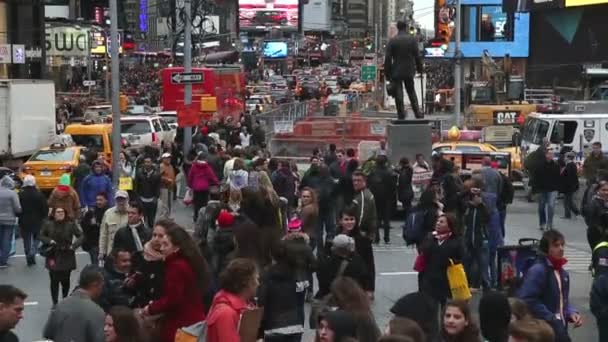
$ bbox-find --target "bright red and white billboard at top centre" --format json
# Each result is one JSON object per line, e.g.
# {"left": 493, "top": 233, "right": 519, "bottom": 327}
{"left": 238, "top": 0, "right": 300, "bottom": 31}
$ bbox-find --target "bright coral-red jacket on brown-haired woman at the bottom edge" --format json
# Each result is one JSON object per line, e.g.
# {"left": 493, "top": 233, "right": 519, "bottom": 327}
{"left": 206, "top": 290, "right": 247, "bottom": 342}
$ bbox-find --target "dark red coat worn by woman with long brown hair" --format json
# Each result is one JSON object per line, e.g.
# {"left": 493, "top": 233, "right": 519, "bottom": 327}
{"left": 149, "top": 251, "right": 205, "bottom": 342}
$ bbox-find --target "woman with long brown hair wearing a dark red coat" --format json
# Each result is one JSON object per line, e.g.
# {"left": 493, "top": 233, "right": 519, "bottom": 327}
{"left": 143, "top": 226, "right": 209, "bottom": 342}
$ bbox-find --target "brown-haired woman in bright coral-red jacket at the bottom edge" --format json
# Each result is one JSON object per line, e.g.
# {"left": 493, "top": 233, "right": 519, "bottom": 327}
{"left": 206, "top": 258, "right": 260, "bottom": 342}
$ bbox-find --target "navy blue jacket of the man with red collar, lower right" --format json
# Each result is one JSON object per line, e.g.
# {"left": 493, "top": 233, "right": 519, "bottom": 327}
{"left": 517, "top": 257, "right": 577, "bottom": 342}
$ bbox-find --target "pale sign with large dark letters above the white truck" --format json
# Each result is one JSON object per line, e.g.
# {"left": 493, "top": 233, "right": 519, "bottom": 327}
{"left": 45, "top": 26, "right": 89, "bottom": 57}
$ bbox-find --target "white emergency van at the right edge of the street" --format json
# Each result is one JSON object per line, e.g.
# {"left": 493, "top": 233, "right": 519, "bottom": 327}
{"left": 521, "top": 101, "right": 608, "bottom": 157}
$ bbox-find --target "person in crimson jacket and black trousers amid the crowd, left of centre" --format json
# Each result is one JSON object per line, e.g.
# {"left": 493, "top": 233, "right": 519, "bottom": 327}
{"left": 188, "top": 152, "right": 219, "bottom": 222}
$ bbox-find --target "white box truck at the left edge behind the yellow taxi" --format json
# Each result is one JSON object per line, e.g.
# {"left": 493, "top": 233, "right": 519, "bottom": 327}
{"left": 0, "top": 79, "right": 56, "bottom": 167}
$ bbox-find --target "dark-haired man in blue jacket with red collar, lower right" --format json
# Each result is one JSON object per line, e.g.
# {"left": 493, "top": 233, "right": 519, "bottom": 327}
{"left": 517, "top": 229, "right": 583, "bottom": 342}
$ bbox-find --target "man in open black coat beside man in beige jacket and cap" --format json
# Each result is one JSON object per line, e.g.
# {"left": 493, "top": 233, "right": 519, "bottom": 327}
{"left": 114, "top": 203, "right": 152, "bottom": 268}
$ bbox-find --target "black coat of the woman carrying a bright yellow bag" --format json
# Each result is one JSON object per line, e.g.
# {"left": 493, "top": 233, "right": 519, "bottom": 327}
{"left": 422, "top": 234, "right": 464, "bottom": 303}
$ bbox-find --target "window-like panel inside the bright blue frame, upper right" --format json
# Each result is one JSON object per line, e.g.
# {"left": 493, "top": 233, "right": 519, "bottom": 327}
{"left": 462, "top": 5, "right": 514, "bottom": 42}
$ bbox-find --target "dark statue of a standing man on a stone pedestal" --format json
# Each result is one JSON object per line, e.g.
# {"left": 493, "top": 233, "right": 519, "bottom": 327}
{"left": 384, "top": 21, "right": 424, "bottom": 120}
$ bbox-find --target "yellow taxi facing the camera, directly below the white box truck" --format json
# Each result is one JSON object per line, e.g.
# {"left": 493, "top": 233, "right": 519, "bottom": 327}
{"left": 21, "top": 144, "right": 83, "bottom": 190}
